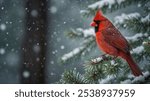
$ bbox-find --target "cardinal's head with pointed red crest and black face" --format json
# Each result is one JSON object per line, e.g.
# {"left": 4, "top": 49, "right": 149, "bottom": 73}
{"left": 91, "top": 10, "right": 106, "bottom": 33}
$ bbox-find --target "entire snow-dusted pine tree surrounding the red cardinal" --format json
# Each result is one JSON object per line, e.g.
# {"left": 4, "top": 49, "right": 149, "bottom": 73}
{"left": 59, "top": 0, "right": 150, "bottom": 84}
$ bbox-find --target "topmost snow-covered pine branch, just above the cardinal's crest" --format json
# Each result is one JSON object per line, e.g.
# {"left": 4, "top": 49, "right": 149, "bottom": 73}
{"left": 80, "top": 0, "right": 143, "bottom": 16}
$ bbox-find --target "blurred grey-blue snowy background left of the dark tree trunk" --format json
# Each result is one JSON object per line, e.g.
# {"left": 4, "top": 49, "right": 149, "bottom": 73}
{"left": 0, "top": 0, "right": 24, "bottom": 83}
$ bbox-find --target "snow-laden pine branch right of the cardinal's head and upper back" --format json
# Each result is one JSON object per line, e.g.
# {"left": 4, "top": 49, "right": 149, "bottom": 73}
{"left": 114, "top": 12, "right": 150, "bottom": 33}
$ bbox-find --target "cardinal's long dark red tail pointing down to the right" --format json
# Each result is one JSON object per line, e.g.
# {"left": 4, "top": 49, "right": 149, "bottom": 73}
{"left": 121, "top": 53, "right": 143, "bottom": 76}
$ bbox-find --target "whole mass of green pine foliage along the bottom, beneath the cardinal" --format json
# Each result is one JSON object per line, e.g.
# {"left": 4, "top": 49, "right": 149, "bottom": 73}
{"left": 59, "top": 56, "right": 150, "bottom": 84}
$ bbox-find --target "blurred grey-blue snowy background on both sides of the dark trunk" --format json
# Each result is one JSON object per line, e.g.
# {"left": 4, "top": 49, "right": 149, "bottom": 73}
{"left": 0, "top": 0, "right": 94, "bottom": 83}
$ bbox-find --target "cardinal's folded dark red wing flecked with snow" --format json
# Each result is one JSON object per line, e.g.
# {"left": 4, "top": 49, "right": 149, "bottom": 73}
{"left": 101, "top": 27, "right": 130, "bottom": 53}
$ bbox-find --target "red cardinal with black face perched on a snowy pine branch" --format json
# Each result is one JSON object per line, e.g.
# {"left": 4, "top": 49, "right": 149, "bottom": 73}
{"left": 91, "top": 10, "right": 143, "bottom": 76}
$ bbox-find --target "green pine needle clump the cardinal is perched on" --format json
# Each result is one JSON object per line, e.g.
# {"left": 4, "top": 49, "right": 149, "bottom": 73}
{"left": 84, "top": 55, "right": 126, "bottom": 83}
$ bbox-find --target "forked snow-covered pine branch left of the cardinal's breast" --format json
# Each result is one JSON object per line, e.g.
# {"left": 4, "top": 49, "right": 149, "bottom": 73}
{"left": 61, "top": 28, "right": 96, "bottom": 62}
